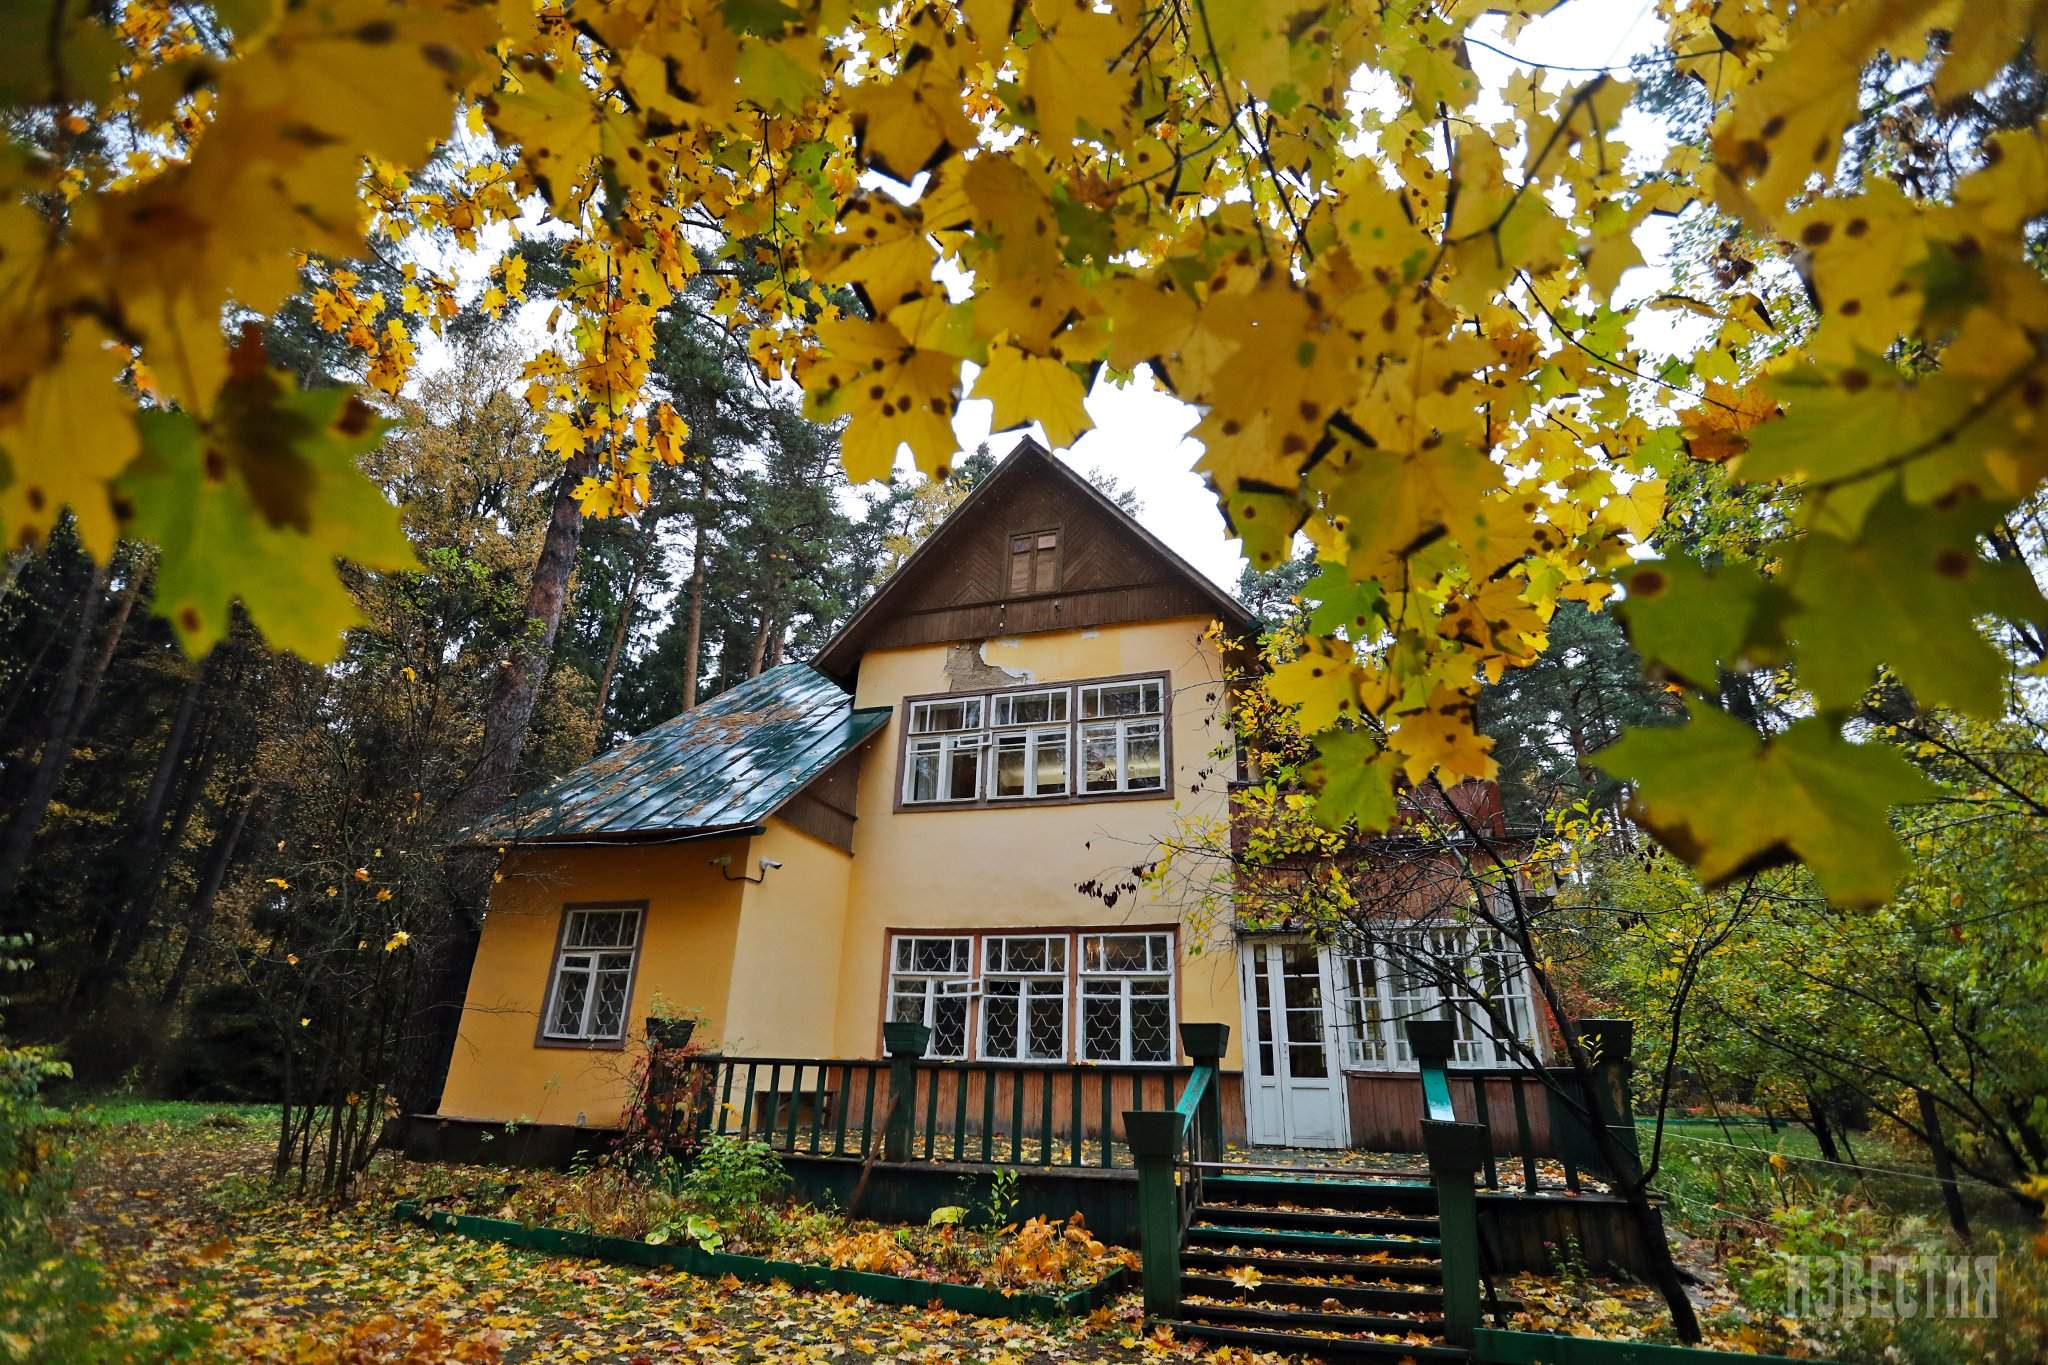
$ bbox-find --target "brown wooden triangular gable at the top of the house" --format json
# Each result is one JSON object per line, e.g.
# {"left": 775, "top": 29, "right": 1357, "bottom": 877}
{"left": 817, "top": 438, "right": 1255, "bottom": 679}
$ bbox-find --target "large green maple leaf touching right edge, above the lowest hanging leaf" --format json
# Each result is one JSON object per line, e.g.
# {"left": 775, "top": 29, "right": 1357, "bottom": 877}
{"left": 1786, "top": 485, "right": 2048, "bottom": 716}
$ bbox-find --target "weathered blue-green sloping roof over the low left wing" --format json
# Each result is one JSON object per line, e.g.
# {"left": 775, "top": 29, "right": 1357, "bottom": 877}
{"left": 459, "top": 663, "right": 889, "bottom": 843}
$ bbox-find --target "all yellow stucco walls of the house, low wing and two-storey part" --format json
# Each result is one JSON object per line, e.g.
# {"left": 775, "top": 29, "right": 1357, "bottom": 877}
{"left": 440, "top": 618, "right": 1241, "bottom": 1126}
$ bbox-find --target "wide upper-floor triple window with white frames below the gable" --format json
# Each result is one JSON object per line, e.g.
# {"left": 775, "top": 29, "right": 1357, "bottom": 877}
{"left": 903, "top": 677, "right": 1167, "bottom": 806}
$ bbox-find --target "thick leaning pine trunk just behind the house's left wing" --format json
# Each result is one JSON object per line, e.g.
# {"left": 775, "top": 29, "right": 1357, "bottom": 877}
{"left": 393, "top": 452, "right": 596, "bottom": 1113}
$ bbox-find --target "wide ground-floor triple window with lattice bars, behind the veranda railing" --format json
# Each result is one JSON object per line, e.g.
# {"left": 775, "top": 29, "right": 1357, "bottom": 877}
{"left": 889, "top": 931, "right": 1180, "bottom": 1064}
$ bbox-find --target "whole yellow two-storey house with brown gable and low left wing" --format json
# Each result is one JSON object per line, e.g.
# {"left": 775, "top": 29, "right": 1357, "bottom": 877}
{"left": 438, "top": 442, "right": 1548, "bottom": 1146}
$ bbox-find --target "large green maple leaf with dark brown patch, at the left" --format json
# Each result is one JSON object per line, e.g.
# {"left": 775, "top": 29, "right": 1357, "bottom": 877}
{"left": 119, "top": 372, "right": 418, "bottom": 663}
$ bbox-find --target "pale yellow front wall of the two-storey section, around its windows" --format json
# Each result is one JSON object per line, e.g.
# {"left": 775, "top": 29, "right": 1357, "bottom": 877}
{"left": 831, "top": 616, "right": 1241, "bottom": 1066}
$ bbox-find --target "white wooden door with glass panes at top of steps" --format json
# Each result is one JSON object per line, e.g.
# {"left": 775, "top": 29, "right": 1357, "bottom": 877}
{"left": 1239, "top": 939, "right": 1350, "bottom": 1148}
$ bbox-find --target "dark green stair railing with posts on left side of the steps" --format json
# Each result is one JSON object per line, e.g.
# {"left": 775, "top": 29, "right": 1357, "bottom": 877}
{"left": 1124, "top": 1023, "right": 1231, "bottom": 1318}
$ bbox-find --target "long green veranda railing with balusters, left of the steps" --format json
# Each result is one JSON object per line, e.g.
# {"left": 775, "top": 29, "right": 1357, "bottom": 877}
{"left": 649, "top": 1039, "right": 1194, "bottom": 1169}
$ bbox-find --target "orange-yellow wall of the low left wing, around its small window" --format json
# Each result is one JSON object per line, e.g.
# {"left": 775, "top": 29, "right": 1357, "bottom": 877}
{"left": 440, "top": 839, "right": 753, "bottom": 1126}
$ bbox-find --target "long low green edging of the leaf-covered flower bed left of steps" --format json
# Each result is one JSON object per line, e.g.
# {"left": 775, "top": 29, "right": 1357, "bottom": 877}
{"left": 391, "top": 1199, "right": 1128, "bottom": 1318}
